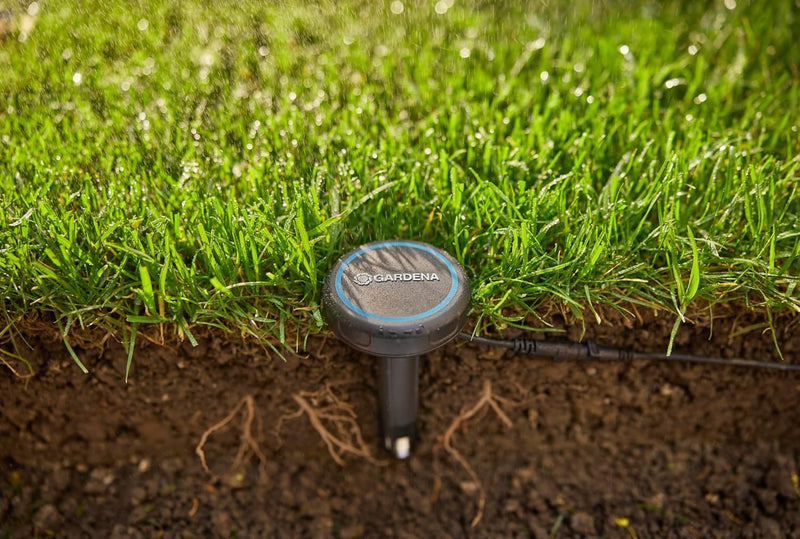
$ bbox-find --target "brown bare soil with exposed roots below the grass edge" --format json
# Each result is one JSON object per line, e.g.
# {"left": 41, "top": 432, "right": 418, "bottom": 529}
{"left": 0, "top": 313, "right": 800, "bottom": 538}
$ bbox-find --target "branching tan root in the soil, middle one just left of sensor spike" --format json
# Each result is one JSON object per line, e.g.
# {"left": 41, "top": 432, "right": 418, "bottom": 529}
{"left": 275, "top": 384, "right": 386, "bottom": 466}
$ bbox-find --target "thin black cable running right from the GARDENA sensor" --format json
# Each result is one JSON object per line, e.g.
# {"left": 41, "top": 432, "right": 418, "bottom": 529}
{"left": 458, "top": 333, "right": 800, "bottom": 371}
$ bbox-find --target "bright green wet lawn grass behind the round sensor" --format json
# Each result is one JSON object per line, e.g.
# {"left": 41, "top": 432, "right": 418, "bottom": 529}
{"left": 0, "top": 0, "right": 800, "bottom": 374}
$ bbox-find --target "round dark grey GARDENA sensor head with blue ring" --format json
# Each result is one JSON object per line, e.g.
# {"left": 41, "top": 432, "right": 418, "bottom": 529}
{"left": 323, "top": 240, "right": 470, "bottom": 357}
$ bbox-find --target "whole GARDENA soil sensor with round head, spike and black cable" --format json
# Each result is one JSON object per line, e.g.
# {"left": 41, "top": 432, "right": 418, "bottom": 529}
{"left": 323, "top": 240, "right": 800, "bottom": 459}
